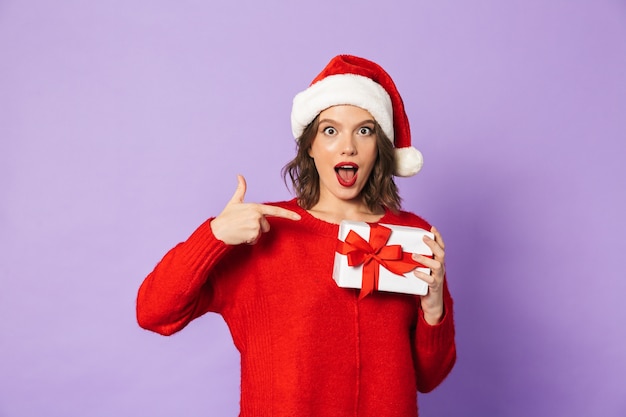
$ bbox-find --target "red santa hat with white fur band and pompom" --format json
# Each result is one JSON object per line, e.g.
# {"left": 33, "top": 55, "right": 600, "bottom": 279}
{"left": 291, "top": 55, "right": 423, "bottom": 177}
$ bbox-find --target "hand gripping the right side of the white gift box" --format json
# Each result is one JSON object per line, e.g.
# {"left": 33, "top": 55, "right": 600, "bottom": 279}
{"left": 413, "top": 227, "right": 446, "bottom": 325}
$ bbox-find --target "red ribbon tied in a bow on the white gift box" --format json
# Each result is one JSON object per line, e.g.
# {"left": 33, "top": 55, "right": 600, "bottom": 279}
{"left": 335, "top": 223, "right": 425, "bottom": 299}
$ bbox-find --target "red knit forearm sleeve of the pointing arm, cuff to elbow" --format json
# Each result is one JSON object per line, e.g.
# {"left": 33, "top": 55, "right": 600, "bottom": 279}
{"left": 137, "top": 219, "right": 232, "bottom": 336}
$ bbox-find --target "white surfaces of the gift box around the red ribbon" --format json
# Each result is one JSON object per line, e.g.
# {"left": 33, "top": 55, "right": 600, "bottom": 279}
{"left": 333, "top": 220, "right": 434, "bottom": 295}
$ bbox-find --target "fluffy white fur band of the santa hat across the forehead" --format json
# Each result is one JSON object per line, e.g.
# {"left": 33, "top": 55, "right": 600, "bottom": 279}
{"left": 291, "top": 74, "right": 394, "bottom": 143}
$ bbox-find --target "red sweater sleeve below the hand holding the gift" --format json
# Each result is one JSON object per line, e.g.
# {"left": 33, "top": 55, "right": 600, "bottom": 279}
{"left": 415, "top": 282, "right": 456, "bottom": 393}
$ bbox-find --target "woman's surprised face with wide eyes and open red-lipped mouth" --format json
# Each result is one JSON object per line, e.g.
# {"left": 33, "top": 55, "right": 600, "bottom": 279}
{"left": 309, "top": 105, "right": 378, "bottom": 206}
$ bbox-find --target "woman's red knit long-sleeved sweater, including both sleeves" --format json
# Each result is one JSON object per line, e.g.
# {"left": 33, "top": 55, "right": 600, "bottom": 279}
{"left": 137, "top": 200, "right": 456, "bottom": 417}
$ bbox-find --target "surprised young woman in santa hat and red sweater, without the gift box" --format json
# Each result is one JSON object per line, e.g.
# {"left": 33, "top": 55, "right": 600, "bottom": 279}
{"left": 137, "top": 55, "right": 456, "bottom": 417}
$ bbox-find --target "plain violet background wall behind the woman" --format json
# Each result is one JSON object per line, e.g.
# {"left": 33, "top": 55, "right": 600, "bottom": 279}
{"left": 0, "top": 0, "right": 626, "bottom": 417}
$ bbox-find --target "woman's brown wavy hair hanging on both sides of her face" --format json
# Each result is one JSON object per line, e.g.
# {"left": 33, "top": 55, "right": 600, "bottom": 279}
{"left": 282, "top": 116, "right": 402, "bottom": 212}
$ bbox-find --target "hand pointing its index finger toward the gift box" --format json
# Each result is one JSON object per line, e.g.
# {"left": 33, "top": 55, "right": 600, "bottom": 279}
{"left": 211, "top": 175, "right": 300, "bottom": 245}
